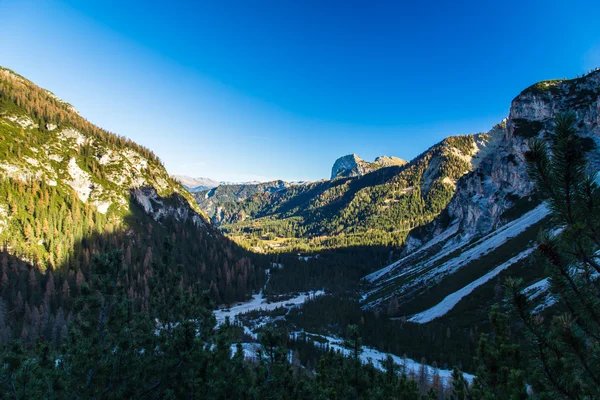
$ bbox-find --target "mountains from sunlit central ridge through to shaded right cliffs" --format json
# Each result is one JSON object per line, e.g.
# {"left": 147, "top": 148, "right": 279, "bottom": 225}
{"left": 196, "top": 71, "right": 600, "bottom": 327}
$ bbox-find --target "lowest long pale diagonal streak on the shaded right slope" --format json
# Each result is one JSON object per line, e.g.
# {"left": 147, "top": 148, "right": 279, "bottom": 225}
{"left": 409, "top": 247, "right": 535, "bottom": 324}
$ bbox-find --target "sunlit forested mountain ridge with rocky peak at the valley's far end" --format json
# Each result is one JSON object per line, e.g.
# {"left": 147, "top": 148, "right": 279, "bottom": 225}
{"left": 196, "top": 136, "right": 490, "bottom": 249}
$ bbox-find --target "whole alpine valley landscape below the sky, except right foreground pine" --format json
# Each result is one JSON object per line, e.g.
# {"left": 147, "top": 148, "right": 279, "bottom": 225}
{"left": 0, "top": 63, "right": 600, "bottom": 400}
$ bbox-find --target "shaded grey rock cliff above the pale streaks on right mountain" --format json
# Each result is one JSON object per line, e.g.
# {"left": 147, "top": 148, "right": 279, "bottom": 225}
{"left": 406, "top": 71, "right": 600, "bottom": 253}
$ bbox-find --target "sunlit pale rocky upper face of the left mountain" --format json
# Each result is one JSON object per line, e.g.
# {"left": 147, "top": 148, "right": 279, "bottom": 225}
{"left": 0, "top": 68, "right": 208, "bottom": 225}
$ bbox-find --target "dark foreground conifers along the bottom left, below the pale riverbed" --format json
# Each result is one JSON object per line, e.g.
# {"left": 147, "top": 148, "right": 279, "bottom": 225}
{"left": 0, "top": 248, "right": 436, "bottom": 400}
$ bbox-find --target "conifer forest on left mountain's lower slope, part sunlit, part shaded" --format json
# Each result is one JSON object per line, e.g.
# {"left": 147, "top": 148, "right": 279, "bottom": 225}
{"left": 0, "top": 179, "right": 266, "bottom": 345}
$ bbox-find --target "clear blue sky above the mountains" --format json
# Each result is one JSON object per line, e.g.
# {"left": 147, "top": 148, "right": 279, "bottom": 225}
{"left": 0, "top": 0, "right": 600, "bottom": 181}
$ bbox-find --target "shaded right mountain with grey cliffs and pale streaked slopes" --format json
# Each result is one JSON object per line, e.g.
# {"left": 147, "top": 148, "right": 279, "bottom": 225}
{"left": 363, "top": 71, "right": 600, "bottom": 325}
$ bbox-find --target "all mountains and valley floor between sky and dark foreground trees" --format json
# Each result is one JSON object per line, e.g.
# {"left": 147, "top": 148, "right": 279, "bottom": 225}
{"left": 0, "top": 62, "right": 600, "bottom": 394}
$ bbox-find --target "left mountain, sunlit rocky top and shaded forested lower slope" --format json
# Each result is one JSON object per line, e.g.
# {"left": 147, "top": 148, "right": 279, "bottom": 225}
{"left": 0, "top": 68, "right": 264, "bottom": 341}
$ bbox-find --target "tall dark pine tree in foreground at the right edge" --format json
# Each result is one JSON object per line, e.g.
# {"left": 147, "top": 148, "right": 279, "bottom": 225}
{"left": 508, "top": 113, "right": 600, "bottom": 399}
